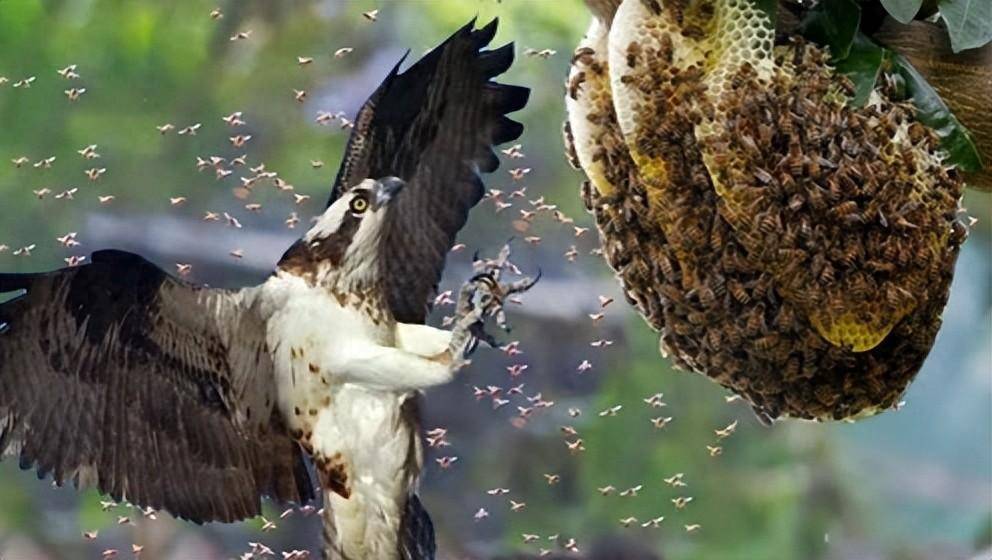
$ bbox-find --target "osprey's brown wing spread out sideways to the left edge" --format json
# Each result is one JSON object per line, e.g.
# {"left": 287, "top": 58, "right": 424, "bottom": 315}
{"left": 0, "top": 251, "right": 313, "bottom": 522}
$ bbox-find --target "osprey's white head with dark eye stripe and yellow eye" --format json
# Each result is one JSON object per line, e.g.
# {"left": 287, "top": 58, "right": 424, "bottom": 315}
{"left": 281, "top": 177, "right": 405, "bottom": 279}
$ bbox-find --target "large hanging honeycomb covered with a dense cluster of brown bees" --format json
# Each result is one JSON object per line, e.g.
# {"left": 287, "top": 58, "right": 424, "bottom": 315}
{"left": 565, "top": 0, "right": 967, "bottom": 421}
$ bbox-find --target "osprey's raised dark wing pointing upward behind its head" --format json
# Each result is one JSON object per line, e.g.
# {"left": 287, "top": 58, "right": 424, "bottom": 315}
{"left": 329, "top": 20, "right": 530, "bottom": 323}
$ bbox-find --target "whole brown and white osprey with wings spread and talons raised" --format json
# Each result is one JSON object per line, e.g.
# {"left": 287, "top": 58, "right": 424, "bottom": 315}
{"left": 0, "top": 21, "right": 530, "bottom": 559}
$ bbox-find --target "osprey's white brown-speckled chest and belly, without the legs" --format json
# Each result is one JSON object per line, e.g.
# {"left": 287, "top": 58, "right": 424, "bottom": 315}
{"left": 258, "top": 274, "right": 421, "bottom": 558}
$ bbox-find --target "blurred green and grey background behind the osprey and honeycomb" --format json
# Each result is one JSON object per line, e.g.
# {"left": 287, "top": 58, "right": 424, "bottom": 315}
{"left": 0, "top": 0, "right": 992, "bottom": 560}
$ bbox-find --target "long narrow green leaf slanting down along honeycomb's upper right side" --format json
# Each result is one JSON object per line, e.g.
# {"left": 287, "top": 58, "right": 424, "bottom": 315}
{"left": 892, "top": 54, "right": 982, "bottom": 171}
